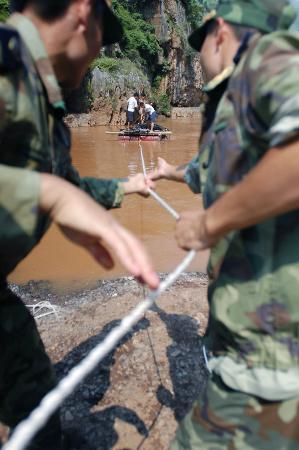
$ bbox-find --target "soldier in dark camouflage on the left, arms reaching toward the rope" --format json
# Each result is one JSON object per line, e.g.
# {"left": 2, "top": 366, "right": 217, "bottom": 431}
{"left": 0, "top": 0, "right": 158, "bottom": 450}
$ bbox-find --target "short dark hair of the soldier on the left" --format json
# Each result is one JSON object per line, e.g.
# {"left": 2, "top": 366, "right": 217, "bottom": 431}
{"left": 10, "top": 0, "right": 102, "bottom": 21}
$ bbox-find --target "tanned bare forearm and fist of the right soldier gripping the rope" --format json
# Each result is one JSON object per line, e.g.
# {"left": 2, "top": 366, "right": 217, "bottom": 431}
{"left": 176, "top": 140, "right": 299, "bottom": 250}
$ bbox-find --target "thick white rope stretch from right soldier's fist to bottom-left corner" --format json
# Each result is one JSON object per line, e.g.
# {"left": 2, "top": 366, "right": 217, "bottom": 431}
{"left": 3, "top": 251, "right": 196, "bottom": 450}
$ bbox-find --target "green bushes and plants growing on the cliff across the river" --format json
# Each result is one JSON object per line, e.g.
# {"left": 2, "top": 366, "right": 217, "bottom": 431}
{"left": 0, "top": 0, "right": 210, "bottom": 115}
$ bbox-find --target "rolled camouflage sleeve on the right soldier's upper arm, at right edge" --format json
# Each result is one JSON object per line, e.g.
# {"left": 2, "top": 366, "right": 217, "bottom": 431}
{"left": 249, "top": 32, "right": 299, "bottom": 148}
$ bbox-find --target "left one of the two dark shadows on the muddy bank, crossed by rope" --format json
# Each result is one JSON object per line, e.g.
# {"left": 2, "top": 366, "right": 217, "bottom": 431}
{"left": 55, "top": 319, "right": 150, "bottom": 450}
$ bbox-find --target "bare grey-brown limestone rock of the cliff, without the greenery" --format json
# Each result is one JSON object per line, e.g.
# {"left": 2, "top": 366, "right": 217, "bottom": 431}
{"left": 68, "top": 0, "right": 203, "bottom": 121}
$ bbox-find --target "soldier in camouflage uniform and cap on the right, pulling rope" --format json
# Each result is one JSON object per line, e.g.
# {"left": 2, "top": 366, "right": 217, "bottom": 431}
{"left": 151, "top": 0, "right": 299, "bottom": 450}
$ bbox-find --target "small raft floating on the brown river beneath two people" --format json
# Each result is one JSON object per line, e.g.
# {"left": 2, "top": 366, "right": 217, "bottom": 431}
{"left": 106, "top": 125, "right": 171, "bottom": 141}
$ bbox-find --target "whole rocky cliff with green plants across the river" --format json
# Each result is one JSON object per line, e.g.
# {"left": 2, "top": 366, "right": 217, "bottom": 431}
{"left": 65, "top": 0, "right": 204, "bottom": 125}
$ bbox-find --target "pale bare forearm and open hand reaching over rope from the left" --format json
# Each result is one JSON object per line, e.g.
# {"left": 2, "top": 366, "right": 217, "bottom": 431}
{"left": 39, "top": 174, "right": 159, "bottom": 289}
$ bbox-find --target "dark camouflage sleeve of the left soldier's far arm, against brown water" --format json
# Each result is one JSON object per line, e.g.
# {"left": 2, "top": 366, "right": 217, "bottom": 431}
{"left": 66, "top": 165, "right": 124, "bottom": 209}
